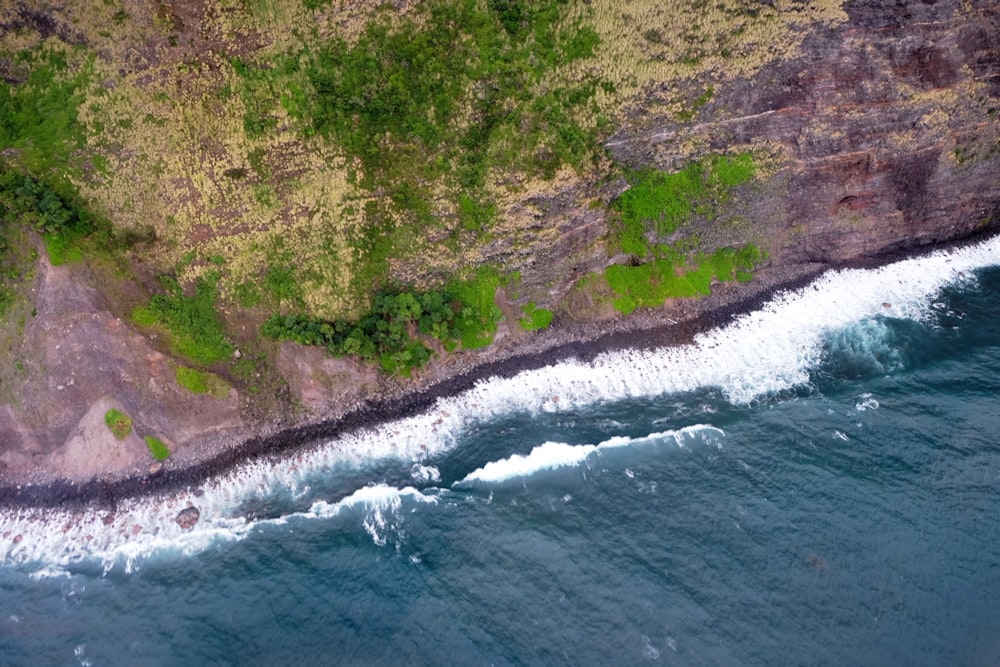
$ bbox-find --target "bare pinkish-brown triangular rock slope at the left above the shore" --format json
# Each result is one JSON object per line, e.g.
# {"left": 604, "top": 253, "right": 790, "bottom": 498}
{"left": 0, "top": 253, "right": 244, "bottom": 482}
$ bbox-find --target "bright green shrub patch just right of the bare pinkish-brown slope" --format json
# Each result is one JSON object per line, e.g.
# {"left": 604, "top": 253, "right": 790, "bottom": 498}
{"left": 132, "top": 272, "right": 233, "bottom": 364}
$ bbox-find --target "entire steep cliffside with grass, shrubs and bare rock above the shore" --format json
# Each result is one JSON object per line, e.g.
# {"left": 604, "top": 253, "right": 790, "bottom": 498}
{"left": 0, "top": 0, "right": 1000, "bottom": 485}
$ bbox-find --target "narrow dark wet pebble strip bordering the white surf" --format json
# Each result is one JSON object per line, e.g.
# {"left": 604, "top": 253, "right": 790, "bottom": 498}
{"left": 0, "top": 231, "right": 996, "bottom": 510}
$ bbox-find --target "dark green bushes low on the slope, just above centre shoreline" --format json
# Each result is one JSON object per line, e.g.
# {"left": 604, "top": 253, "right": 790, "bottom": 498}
{"left": 262, "top": 269, "right": 502, "bottom": 375}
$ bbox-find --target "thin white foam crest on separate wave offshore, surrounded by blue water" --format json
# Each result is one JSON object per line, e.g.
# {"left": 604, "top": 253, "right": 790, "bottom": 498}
{"left": 456, "top": 424, "right": 725, "bottom": 486}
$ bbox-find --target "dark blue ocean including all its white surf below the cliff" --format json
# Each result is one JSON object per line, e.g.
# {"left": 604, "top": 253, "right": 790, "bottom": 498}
{"left": 0, "top": 239, "right": 1000, "bottom": 666}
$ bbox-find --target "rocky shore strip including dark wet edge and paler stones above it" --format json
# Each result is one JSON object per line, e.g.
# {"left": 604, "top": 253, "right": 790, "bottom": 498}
{"left": 0, "top": 227, "right": 985, "bottom": 508}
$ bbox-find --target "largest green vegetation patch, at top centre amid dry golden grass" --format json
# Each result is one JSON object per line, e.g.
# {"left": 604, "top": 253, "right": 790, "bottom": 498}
{"left": 227, "top": 0, "right": 608, "bottom": 298}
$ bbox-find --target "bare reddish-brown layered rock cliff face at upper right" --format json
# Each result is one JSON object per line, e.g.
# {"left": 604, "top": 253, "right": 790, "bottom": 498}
{"left": 609, "top": 0, "right": 1000, "bottom": 263}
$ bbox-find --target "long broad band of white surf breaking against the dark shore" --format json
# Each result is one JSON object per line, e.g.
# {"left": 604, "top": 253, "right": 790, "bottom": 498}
{"left": 0, "top": 237, "right": 1000, "bottom": 576}
